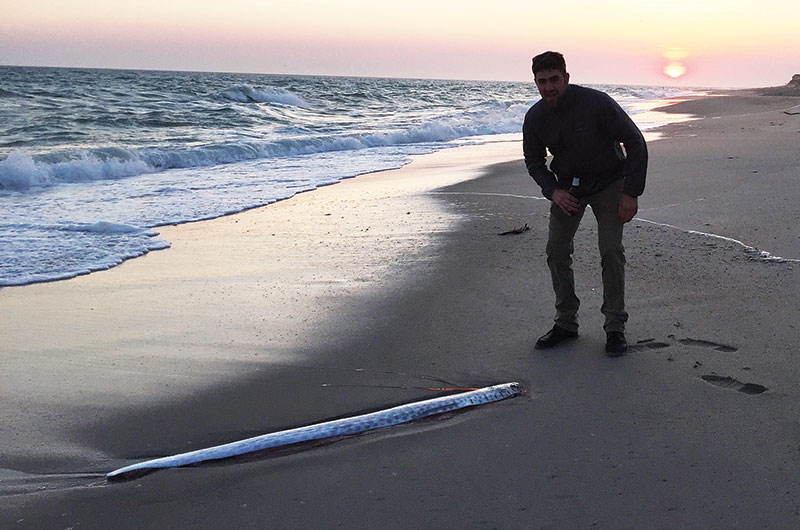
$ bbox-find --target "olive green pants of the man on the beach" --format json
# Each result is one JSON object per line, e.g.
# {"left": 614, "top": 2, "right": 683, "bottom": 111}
{"left": 547, "top": 179, "right": 628, "bottom": 332}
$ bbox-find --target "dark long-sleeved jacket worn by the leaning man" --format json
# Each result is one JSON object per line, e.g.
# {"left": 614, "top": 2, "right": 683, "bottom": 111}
{"left": 522, "top": 85, "right": 647, "bottom": 199}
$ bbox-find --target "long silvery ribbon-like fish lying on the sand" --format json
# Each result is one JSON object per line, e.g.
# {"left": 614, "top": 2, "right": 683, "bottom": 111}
{"left": 106, "top": 383, "right": 522, "bottom": 481}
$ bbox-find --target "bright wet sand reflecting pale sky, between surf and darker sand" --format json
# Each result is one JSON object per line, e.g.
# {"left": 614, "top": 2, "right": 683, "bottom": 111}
{"left": 0, "top": 138, "right": 517, "bottom": 472}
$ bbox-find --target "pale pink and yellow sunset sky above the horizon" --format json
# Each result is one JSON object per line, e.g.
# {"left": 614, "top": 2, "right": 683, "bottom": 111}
{"left": 0, "top": 0, "right": 800, "bottom": 87}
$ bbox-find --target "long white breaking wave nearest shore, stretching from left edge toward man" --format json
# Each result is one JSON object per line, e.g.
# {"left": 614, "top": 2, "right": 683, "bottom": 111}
{"left": 0, "top": 101, "right": 528, "bottom": 192}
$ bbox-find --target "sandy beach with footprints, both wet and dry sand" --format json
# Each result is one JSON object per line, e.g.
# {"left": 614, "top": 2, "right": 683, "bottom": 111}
{"left": 0, "top": 91, "right": 800, "bottom": 529}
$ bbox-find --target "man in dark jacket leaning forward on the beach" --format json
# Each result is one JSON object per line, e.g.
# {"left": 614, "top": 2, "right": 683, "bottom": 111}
{"left": 522, "top": 51, "right": 647, "bottom": 357}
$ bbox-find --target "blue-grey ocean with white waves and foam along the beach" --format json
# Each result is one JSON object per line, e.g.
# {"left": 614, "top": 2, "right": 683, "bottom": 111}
{"left": 0, "top": 67, "right": 702, "bottom": 286}
